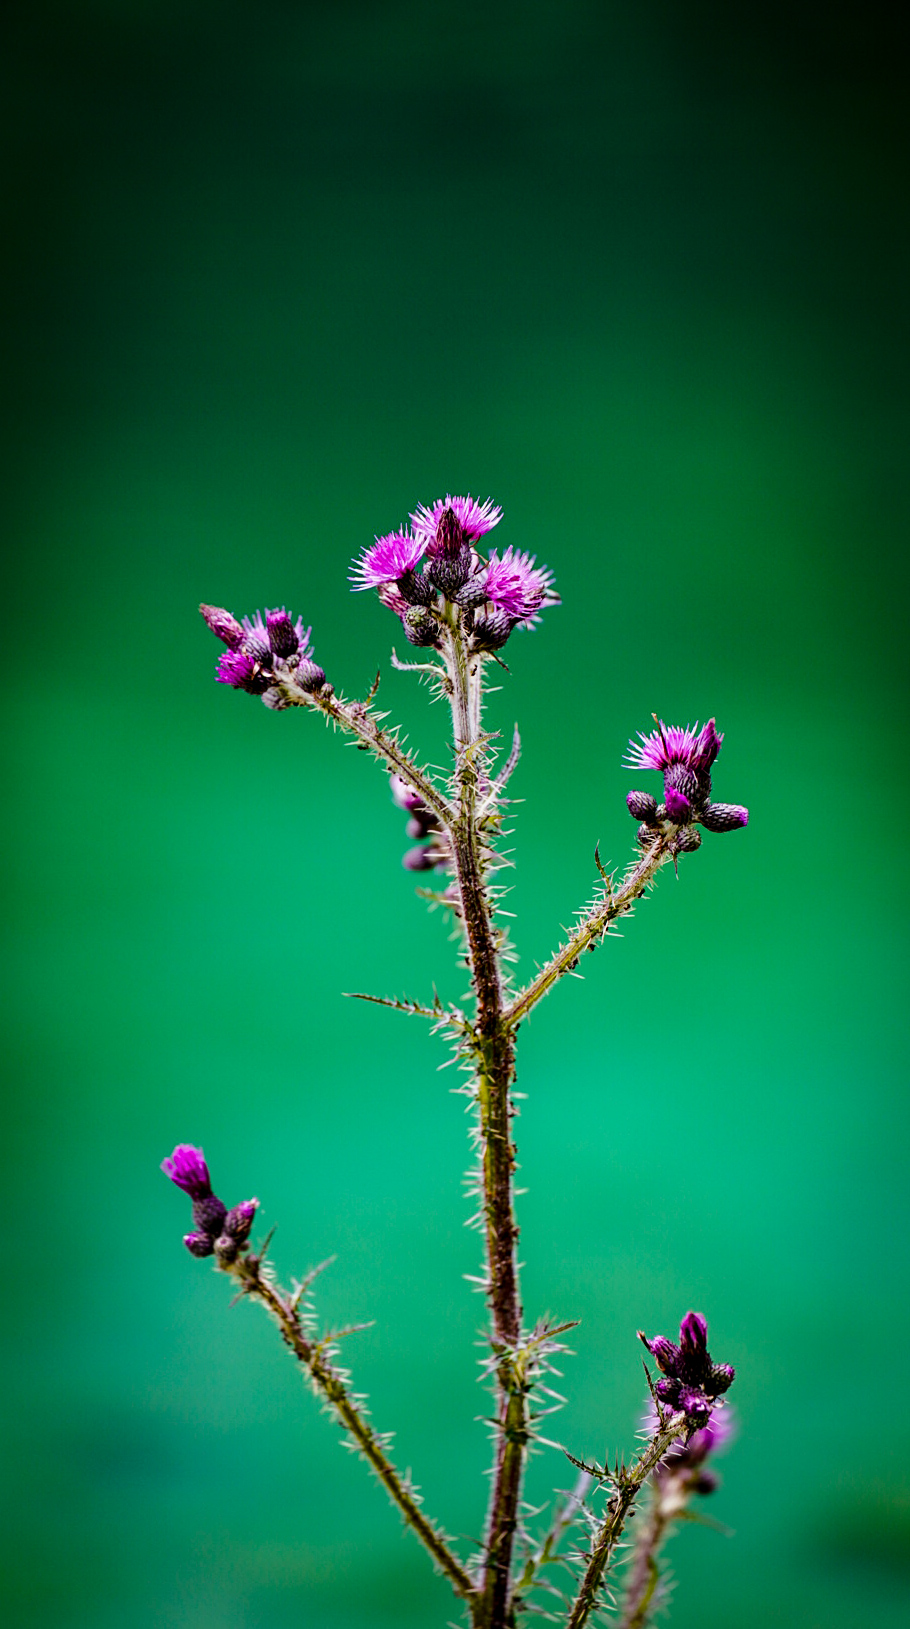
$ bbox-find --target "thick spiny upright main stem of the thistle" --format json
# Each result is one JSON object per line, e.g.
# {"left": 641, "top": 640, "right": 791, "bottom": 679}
{"left": 446, "top": 624, "right": 527, "bottom": 1629}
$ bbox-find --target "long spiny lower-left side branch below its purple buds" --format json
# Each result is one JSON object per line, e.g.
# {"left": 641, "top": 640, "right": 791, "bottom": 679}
{"left": 223, "top": 1256, "right": 475, "bottom": 1600}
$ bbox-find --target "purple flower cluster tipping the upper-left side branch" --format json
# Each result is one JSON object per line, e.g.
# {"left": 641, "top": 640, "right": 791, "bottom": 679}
{"left": 199, "top": 606, "right": 326, "bottom": 712}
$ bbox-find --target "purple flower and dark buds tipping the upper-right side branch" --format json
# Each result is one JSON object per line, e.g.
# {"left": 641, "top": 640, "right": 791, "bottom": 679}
{"left": 625, "top": 718, "right": 749, "bottom": 854}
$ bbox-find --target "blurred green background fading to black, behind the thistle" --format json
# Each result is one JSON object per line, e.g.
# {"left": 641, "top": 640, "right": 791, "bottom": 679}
{"left": 2, "top": 0, "right": 910, "bottom": 1629}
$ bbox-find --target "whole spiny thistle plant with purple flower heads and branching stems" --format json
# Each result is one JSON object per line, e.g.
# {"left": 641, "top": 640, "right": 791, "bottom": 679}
{"left": 163, "top": 495, "right": 749, "bottom": 1629}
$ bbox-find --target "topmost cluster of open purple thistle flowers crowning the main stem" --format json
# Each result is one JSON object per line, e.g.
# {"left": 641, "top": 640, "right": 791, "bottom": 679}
{"left": 352, "top": 494, "right": 560, "bottom": 652}
